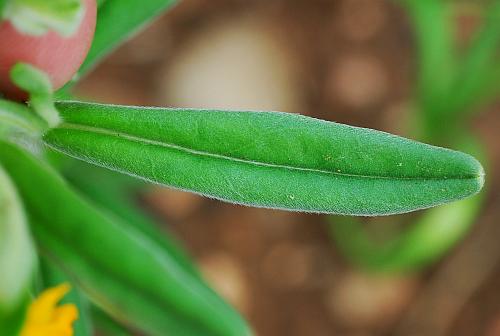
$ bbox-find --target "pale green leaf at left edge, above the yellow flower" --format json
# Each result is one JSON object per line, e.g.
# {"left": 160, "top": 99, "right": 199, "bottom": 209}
{"left": 0, "top": 163, "right": 36, "bottom": 336}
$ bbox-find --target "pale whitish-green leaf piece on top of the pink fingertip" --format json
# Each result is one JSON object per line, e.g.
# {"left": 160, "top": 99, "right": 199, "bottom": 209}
{"left": 0, "top": 0, "right": 84, "bottom": 36}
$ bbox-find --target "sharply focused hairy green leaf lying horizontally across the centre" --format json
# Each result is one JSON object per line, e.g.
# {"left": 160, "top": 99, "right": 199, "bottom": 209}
{"left": 44, "top": 102, "right": 483, "bottom": 215}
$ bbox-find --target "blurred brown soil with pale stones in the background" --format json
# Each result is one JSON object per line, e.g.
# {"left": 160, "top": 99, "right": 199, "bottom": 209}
{"left": 78, "top": 0, "right": 500, "bottom": 336}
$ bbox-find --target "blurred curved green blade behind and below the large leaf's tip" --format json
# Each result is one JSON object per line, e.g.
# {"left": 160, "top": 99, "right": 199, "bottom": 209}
{"left": 329, "top": 132, "right": 488, "bottom": 273}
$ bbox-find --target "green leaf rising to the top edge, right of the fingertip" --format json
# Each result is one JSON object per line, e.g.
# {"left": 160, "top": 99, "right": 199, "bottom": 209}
{"left": 79, "top": 0, "right": 177, "bottom": 75}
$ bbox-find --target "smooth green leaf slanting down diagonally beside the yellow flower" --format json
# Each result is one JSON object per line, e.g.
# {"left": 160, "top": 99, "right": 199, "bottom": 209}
{"left": 0, "top": 142, "right": 250, "bottom": 336}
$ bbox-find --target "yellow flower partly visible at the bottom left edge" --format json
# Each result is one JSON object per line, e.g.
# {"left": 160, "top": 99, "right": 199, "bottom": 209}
{"left": 20, "top": 284, "right": 78, "bottom": 336}
